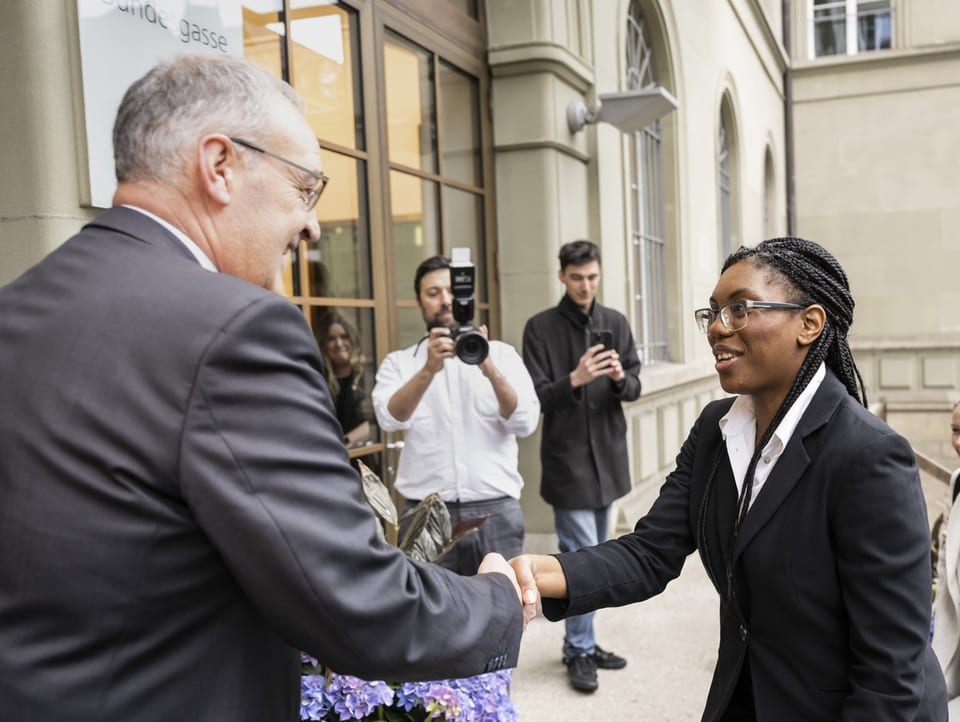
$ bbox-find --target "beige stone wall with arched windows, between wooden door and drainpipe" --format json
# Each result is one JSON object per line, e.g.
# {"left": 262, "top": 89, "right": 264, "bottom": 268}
{"left": 486, "top": 0, "right": 786, "bottom": 531}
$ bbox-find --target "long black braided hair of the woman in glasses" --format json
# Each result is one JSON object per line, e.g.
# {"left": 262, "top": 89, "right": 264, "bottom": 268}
{"left": 698, "top": 237, "right": 867, "bottom": 600}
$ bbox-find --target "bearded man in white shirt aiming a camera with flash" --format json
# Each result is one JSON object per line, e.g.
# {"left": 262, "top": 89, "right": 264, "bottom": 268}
{"left": 372, "top": 256, "right": 540, "bottom": 575}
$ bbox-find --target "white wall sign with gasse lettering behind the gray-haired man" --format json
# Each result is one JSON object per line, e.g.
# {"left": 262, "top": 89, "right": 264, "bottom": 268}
{"left": 77, "top": 0, "right": 243, "bottom": 208}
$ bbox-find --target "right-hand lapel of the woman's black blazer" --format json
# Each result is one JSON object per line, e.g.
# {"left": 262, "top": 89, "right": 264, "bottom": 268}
{"left": 733, "top": 369, "right": 847, "bottom": 561}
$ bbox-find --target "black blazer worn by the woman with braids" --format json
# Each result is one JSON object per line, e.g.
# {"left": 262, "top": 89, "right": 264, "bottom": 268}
{"left": 544, "top": 371, "right": 947, "bottom": 722}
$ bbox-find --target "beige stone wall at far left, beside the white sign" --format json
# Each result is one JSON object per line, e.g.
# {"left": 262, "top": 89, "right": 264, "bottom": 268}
{"left": 0, "top": 1, "right": 95, "bottom": 284}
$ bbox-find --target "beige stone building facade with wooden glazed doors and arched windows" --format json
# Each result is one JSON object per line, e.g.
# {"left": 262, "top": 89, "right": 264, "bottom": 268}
{"left": 0, "top": 0, "right": 960, "bottom": 531}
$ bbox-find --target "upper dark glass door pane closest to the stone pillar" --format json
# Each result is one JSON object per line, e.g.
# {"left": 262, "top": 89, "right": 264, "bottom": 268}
{"left": 439, "top": 63, "right": 483, "bottom": 186}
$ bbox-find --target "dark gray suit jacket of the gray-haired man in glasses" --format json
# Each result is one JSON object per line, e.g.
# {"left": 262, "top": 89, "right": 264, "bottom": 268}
{"left": 0, "top": 208, "right": 521, "bottom": 722}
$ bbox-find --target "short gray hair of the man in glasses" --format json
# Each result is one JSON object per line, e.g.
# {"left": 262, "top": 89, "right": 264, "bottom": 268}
{"left": 113, "top": 55, "right": 303, "bottom": 182}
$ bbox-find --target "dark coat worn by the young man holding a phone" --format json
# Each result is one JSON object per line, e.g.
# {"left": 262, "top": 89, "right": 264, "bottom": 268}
{"left": 523, "top": 294, "right": 640, "bottom": 509}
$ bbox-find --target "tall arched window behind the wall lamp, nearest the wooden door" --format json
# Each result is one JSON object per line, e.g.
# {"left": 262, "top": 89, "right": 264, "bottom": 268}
{"left": 626, "top": 0, "right": 669, "bottom": 364}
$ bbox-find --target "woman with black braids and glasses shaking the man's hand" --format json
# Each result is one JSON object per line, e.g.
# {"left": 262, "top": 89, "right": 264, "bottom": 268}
{"left": 512, "top": 238, "right": 947, "bottom": 722}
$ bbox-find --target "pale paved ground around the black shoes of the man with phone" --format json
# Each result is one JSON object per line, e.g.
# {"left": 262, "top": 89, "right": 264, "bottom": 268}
{"left": 511, "top": 534, "right": 719, "bottom": 722}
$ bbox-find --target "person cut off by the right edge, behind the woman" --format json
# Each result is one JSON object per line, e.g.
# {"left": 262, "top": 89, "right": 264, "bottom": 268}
{"left": 933, "top": 401, "right": 960, "bottom": 720}
